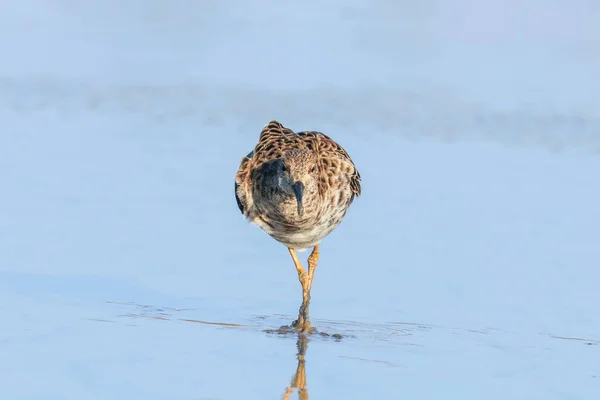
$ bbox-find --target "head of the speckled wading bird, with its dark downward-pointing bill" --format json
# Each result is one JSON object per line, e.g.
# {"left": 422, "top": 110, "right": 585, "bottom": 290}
{"left": 279, "top": 149, "right": 318, "bottom": 217}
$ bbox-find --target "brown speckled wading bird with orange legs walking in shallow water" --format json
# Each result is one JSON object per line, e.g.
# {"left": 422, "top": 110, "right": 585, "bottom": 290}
{"left": 235, "top": 120, "right": 361, "bottom": 333}
